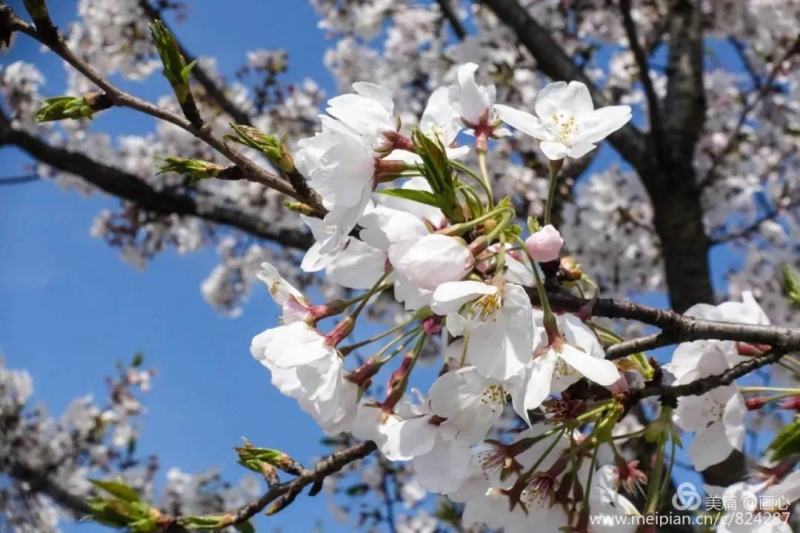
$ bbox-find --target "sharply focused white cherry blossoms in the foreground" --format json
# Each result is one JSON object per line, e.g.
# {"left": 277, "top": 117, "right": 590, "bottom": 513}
{"left": 242, "top": 63, "right": 792, "bottom": 531}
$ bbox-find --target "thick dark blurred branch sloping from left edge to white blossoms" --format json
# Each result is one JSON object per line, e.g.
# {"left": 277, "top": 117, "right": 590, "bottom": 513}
{"left": 0, "top": 109, "right": 311, "bottom": 249}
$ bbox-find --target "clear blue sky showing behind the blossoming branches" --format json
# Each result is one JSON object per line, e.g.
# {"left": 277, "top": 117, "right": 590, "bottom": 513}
{"left": 0, "top": 0, "right": 764, "bottom": 532}
